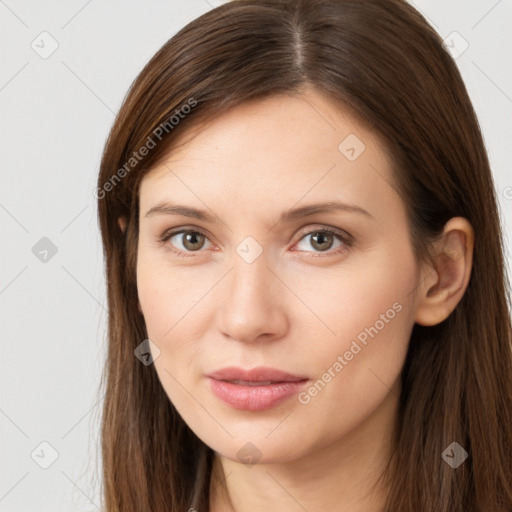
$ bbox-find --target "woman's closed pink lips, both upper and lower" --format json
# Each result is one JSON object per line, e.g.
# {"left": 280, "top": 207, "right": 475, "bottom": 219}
{"left": 207, "top": 367, "right": 309, "bottom": 411}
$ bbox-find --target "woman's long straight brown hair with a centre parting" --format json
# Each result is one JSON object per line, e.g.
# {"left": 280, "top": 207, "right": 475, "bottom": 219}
{"left": 96, "top": 0, "right": 512, "bottom": 512}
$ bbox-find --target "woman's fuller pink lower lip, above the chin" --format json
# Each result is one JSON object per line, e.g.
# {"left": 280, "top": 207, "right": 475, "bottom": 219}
{"left": 210, "top": 378, "right": 307, "bottom": 411}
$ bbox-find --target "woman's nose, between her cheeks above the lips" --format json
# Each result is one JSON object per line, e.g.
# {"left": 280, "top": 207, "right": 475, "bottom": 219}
{"left": 218, "top": 248, "right": 288, "bottom": 343}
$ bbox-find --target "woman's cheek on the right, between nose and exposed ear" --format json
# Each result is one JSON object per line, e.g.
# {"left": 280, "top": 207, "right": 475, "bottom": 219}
{"left": 292, "top": 251, "right": 416, "bottom": 404}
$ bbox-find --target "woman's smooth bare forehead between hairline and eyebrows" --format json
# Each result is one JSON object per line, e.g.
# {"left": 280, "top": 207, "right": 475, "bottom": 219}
{"left": 140, "top": 91, "right": 400, "bottom": 224}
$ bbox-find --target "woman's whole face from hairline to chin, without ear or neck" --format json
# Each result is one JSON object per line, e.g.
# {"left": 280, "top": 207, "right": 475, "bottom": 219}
{"left": 137, "top": 90, "right": 420, "bottom": 462}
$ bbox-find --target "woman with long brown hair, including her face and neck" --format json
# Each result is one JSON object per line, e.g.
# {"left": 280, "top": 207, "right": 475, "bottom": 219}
{"left": 96, "top": 0, "right": 512, "bottom": 512}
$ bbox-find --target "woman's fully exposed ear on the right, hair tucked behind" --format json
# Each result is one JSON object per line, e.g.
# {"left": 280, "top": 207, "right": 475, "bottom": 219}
{"left": 415, "top": 217, "right": 474, "bottom": 326}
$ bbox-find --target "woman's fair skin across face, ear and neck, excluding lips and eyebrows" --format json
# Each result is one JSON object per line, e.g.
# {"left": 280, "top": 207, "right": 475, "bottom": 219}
{"left": 125, "top": 90, "right": 474, "bottom": 512}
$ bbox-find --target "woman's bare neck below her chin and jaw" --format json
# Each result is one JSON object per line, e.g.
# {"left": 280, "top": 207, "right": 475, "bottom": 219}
{"left": 210, "top": 378, "right": 398, "bottom": 512}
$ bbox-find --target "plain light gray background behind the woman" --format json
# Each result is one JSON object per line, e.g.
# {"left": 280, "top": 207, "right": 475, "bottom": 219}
{"left": 0, "top": 0, "right": 512, "bottom": 512}
